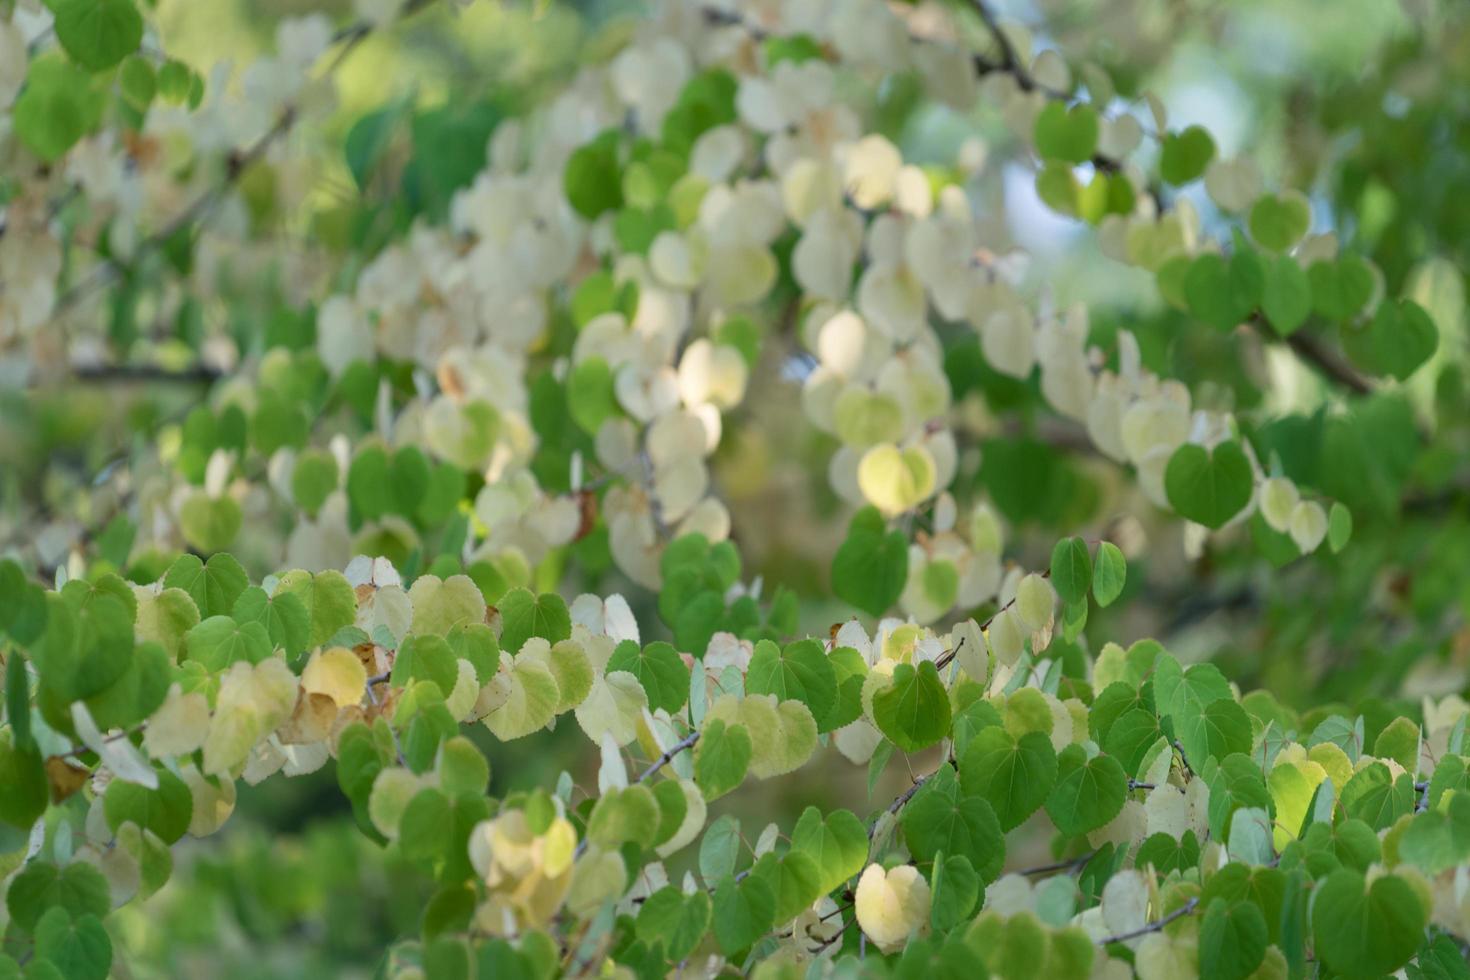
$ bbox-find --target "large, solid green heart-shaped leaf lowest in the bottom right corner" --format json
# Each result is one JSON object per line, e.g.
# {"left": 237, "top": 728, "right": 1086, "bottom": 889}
{"left": 1311, "top": 868, "right": 1427, "bottom": 977}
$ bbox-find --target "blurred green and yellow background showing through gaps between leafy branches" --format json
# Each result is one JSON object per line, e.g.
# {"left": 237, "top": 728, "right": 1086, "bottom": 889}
{"left": 0, "top": 0, "right": 1470, "bottom": 979}
